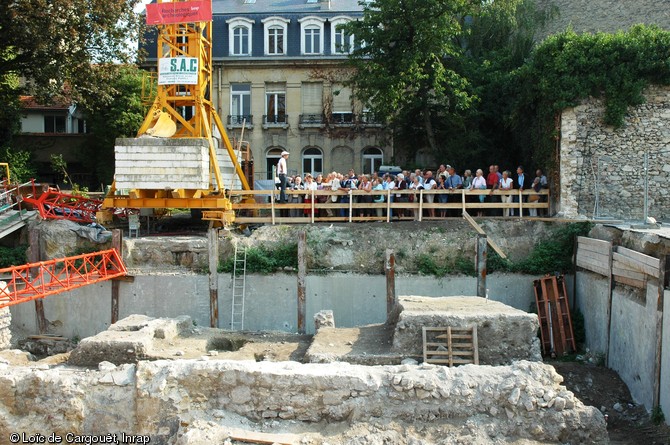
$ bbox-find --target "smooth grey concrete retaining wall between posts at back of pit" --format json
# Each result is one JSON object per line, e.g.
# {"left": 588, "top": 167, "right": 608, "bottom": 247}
{"left": 7, "top": 273, "right": 536, "bottom": 338}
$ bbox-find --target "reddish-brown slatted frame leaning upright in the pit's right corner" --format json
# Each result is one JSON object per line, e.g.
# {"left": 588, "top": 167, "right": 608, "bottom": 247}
{"left": 533, "top": 275, "right": 577, "bottom": 355}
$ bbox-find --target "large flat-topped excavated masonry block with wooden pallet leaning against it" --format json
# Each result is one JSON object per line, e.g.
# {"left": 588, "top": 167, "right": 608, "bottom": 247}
{"left": 391, "top": 296, "right": 542, "bottom": 365}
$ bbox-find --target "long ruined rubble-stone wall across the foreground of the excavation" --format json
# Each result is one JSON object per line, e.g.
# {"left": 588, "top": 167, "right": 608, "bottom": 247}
{"left": 0, "top": 360, "right": 607, "bottom": 444}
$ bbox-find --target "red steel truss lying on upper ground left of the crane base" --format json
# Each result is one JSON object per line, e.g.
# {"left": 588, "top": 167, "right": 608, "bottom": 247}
{"left": 23, "top": 182, "right": 102, "bottom": 223}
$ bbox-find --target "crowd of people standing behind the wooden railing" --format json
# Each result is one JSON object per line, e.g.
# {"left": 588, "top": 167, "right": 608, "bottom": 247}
{"left": 277, "top": 152, "right": 548, "bottom": 217}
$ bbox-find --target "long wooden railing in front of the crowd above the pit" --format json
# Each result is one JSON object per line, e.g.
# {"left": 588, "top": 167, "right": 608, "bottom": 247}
{"left": 230, "top": 189, "right": 549, "bottom": 224}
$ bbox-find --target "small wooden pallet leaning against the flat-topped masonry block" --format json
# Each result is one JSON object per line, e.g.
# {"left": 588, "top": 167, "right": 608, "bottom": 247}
{"left": 422, "top": 325, "right": 479, "bottom": 367}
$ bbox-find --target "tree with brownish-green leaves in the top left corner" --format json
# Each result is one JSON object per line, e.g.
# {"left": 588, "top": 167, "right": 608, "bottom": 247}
{"left": 0, "top": 0, "right": 142, "bottom": 107}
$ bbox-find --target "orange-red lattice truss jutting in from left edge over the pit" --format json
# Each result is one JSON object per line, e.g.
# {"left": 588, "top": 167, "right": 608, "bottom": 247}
{"left": 0, "top": 249, "right": 128, "bottom": 308}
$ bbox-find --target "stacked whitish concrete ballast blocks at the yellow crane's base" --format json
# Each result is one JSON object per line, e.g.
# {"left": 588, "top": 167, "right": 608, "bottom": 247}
{"left": 114, "top": 137, "right": 210, "bottom": 190}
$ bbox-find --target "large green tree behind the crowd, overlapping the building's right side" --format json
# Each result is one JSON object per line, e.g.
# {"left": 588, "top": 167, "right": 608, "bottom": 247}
{"left": 347, "top": 0, "right": 546, "bottom": 165}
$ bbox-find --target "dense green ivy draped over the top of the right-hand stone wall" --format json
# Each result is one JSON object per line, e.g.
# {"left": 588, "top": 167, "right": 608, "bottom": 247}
{"left": 507, "top": 25, "right": 670, "bottom": 164}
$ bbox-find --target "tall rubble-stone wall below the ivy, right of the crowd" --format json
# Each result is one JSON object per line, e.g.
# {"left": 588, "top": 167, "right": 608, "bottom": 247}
{"left": 559, "top": 86, "right": 670, "bottom": 221}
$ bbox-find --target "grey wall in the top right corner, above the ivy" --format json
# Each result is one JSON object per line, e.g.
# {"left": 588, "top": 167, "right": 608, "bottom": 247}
{"left": 537, "top": 0, "right": 670, "bottom": 39}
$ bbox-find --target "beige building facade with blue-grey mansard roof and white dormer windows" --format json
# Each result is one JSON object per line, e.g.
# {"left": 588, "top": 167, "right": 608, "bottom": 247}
{"left": 148, "top": 0, "right": 393, "bottom": 179}
